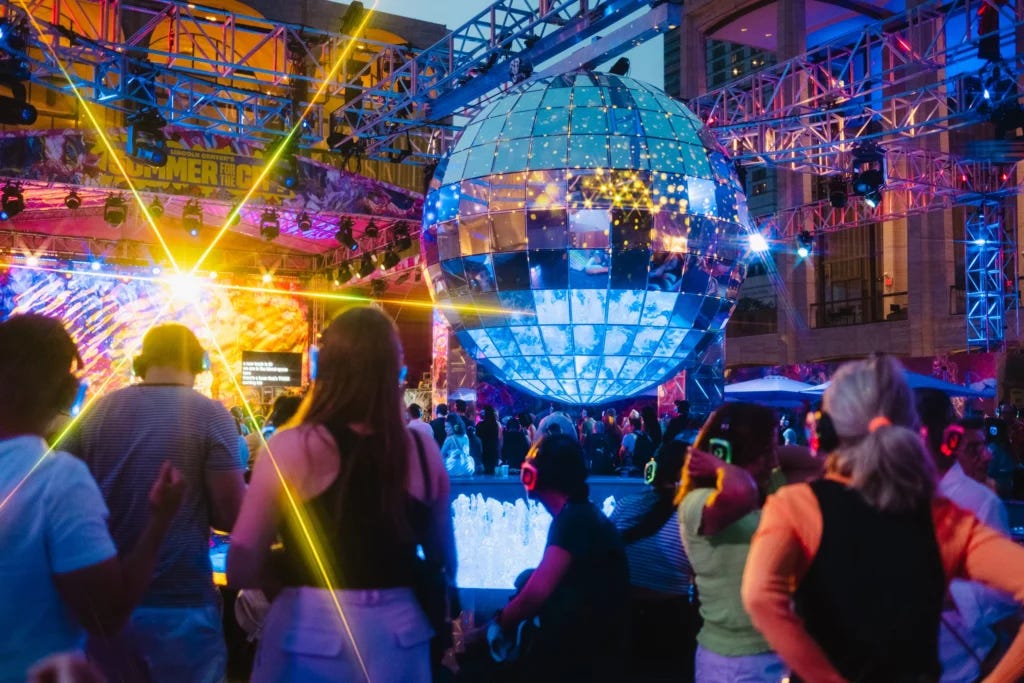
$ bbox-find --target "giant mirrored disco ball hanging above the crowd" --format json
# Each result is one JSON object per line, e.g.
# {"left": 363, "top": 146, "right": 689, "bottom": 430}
{"left": 421, "top": 72, "right": 749, "bottom": 403}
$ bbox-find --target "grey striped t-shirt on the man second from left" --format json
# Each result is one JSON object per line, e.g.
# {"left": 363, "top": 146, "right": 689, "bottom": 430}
{"left": 60, "top": 384, "right": 241, "bottom": 607}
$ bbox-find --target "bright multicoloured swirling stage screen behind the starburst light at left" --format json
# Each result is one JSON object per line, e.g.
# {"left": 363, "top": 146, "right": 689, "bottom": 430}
{"left": 0, "top": 265, "right": 309, "bottom": 405}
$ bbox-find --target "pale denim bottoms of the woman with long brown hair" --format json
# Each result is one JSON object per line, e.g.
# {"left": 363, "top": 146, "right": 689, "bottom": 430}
{"left": 252, "top": 588, "right": 434, "bottom": 683}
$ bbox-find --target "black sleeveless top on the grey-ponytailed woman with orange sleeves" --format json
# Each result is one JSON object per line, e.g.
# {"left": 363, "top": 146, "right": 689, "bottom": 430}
{"left": 793, "top": 479, "right": 946, "bottom": 683}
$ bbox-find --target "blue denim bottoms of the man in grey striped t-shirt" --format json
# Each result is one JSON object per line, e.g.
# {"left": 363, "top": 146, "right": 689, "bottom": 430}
{"left": 87, "top": 605, "right": 227, "bottom": 683}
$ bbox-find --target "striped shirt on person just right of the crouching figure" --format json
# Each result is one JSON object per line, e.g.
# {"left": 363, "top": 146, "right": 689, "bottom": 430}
{"left": 611, "top": 490, "right": 693, "bottom": 595}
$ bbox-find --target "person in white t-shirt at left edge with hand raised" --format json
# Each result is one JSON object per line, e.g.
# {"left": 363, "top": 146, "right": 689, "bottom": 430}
{"left": 0, "top": 314, "right": 183, "bottom": 683}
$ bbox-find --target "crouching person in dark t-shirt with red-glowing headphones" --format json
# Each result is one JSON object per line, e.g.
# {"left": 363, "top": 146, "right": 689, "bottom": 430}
{"left": 492, "top": 432, "right": 629, "bottom": 683}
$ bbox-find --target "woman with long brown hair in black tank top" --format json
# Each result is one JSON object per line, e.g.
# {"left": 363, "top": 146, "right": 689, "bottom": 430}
{"left": 234, "top": 307, "right": 456, "bottom": 683}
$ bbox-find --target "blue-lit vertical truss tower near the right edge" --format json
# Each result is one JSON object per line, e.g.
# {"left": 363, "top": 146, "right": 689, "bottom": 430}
{"left": 965, "top": 201, "right": 1017, "bottom": 351}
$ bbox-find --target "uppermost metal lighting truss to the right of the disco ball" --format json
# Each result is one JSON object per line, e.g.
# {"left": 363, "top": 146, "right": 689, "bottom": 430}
{"left": 690, "top": 0, "right": 1024, "bottom": 173}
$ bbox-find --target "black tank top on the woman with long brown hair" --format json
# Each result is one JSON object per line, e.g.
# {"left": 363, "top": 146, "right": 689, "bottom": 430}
{"left": 281, "top": 424, "right": 430, "bottom": 590}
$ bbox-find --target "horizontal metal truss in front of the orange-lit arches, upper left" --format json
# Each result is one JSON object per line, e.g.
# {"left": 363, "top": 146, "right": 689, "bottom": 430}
{"left": 0, "top": 0, "right": 452, "bottom": 158}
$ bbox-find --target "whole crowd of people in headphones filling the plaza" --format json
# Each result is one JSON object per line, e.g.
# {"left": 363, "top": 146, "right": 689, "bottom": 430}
{"left": 0, "top": 307, "right": 1024, "bottom": 683}
